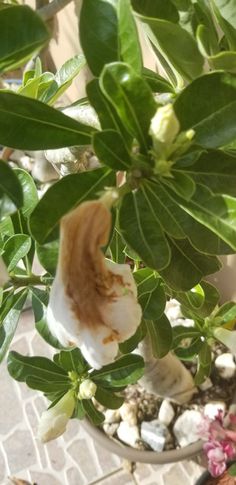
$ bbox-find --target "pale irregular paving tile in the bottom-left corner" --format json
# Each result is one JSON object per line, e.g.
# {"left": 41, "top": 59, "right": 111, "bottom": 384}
{"left": 2, "top": 430, "right": 37, "bottom": 472}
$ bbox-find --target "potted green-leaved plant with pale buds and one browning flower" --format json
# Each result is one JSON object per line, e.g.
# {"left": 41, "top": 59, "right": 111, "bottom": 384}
{"left": 0, "top": 0, "right": 236, "bottom": 463}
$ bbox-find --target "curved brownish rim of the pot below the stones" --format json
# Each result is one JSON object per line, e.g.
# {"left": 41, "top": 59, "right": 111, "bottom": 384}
{"left": 81, "top": 418, "right": 203, "bottom": 465}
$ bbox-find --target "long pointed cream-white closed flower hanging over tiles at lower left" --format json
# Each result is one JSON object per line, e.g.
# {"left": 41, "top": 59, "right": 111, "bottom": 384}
{"left": 38, "top": 390, "right": 75, "bottom": 443}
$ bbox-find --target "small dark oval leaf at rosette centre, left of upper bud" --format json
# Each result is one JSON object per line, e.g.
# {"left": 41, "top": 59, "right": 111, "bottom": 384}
{"left": 93, "top": 130, "right": 132, "bottom": 170}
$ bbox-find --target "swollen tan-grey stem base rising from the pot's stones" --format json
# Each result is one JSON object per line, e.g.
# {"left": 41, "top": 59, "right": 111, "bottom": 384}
{"left": 139, "top": 337, "right": 196, "bottom": 404}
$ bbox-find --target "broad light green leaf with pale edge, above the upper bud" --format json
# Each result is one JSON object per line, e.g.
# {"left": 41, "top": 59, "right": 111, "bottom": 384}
{"left": 141, "top": 16, "right": 204, "bottom": 84}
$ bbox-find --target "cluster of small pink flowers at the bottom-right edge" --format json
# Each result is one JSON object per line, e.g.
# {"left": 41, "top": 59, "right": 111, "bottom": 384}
{"left": 199, "top": 410, "right": 236, "bottom": 477}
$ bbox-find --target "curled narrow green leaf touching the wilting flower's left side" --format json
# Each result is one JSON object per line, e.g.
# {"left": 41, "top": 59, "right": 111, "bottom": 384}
{"left": 31, "top": 288, "right": 63, "bottom": 349}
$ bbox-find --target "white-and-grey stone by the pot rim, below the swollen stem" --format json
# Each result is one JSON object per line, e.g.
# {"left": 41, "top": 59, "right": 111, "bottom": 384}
{"left": 141, "top": 419, "right": 168, "bottom": 452}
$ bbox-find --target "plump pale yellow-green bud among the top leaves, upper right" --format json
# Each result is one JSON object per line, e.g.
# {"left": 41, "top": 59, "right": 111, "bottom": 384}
{"left": 149, "top": 103, "right": 180, "bottom": 148}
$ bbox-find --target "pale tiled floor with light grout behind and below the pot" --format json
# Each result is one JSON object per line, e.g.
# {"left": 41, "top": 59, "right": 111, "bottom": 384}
{"left": 0, "top": 311, "right": 206, "bottom": 485}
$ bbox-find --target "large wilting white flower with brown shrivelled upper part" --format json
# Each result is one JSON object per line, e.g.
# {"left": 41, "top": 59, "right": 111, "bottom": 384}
{"left": 47, "top": 201, "right": 141, "bottom": 369}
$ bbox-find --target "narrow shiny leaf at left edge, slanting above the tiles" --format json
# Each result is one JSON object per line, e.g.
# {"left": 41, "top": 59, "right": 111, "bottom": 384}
{"left": 0, "top": 290, "right": 28, "bottom": 362}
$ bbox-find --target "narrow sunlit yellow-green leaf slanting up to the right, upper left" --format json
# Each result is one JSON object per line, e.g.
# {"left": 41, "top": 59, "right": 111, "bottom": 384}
{"left": 39, "top": 54, "right": 86, "bottom": 105}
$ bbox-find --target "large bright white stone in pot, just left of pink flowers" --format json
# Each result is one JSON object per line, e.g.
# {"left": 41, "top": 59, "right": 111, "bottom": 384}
{"left": 173, "top": 409, "right": 202, "bottom": 447}
